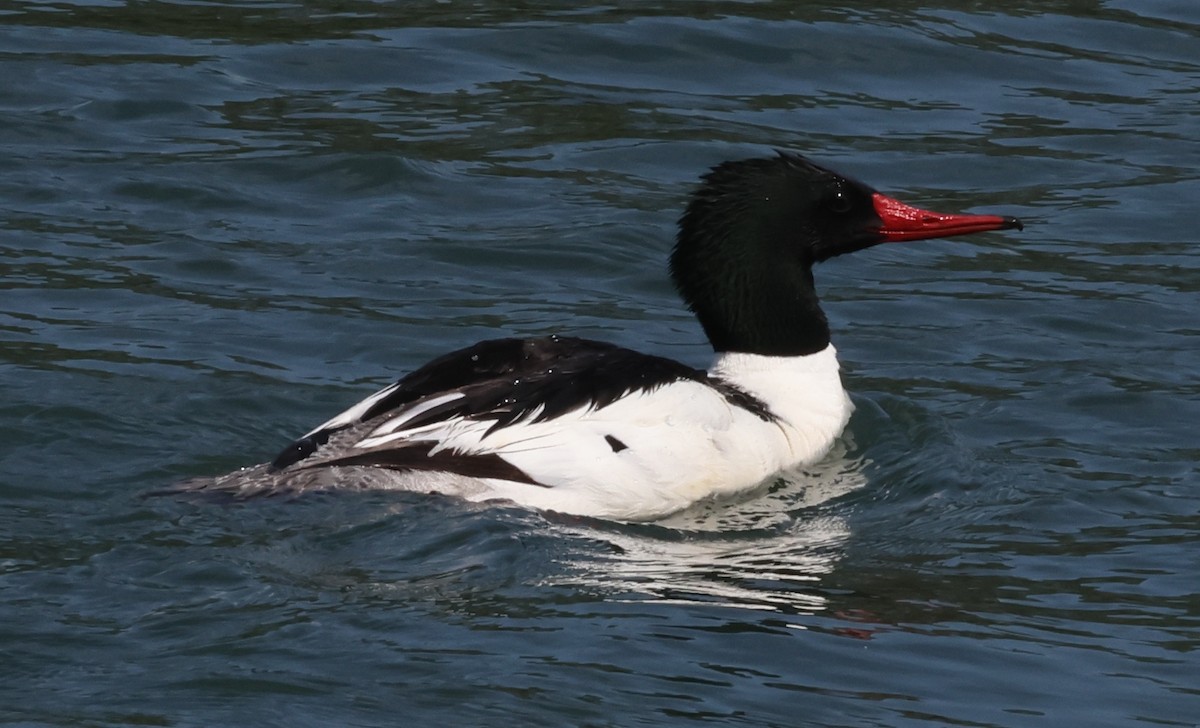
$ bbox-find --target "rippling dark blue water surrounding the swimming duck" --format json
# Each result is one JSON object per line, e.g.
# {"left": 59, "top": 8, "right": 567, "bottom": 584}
{"left": 0, "top": 0, "right": 1200, "bottom": 727}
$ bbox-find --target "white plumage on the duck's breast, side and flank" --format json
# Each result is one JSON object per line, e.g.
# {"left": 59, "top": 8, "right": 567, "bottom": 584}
{"left": 348, "top": 345, "right": 853, "bottom": 521}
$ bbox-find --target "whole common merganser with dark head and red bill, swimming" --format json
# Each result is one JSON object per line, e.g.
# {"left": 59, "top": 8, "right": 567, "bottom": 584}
{"left": 190, "top": 152, "right": 1021, "bottom": 521}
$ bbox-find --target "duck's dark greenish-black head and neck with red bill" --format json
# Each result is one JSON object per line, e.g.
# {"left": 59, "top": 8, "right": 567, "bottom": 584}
{"left": 671, "top": 152, "right": 1021, "bottom": 356}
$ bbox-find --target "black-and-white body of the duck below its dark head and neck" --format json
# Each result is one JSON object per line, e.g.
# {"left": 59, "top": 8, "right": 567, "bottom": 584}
{"left": 250, "top": 337, "right": 851, "bottom": 521}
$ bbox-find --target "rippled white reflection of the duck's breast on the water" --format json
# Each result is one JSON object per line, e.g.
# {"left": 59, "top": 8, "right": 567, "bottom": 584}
{"left": 551, "top": 441, "right": 868, "bottom": 614}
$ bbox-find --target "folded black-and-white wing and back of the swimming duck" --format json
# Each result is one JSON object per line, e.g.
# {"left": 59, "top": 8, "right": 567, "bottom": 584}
{"left": 271, "top": 336, "right": 770, "bottom": 472}
